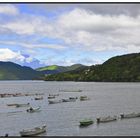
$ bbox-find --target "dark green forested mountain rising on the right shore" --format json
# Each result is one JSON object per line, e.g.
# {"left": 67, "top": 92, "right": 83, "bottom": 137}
{"left": 45, "top": 53, "right": 140, "bottom": 82}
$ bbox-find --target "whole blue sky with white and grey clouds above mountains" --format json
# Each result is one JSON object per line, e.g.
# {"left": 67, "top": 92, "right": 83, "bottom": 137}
{"left": 0, "top": 3, "right": 140, "bottom": 68}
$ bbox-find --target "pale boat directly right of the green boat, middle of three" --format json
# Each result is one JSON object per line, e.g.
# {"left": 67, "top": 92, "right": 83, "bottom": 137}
{"left": 96, "top": 116, "right": 117, "bottom": 123}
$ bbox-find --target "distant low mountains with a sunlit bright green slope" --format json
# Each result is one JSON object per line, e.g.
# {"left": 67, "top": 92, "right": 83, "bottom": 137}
{"left": 36, "top": 64, "right": 86, "bottom": 74}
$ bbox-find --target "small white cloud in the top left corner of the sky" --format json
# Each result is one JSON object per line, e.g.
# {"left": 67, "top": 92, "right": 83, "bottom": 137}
{"left": 0, "top": 4, "right": 19, "bottom": 15}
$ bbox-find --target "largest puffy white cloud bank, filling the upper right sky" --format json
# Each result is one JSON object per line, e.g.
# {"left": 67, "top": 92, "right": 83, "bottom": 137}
{"left": 53, "top": 9, "right": 140, "bottom": 52}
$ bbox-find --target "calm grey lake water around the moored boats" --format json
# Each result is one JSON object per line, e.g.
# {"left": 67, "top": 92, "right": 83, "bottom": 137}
{"left": 0, "top": 81, "right": 140, "bottom": 137}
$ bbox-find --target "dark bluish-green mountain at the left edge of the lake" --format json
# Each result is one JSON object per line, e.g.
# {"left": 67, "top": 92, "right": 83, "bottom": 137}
{"left": 0, "top": 61, "right": 43, "bottom": 80}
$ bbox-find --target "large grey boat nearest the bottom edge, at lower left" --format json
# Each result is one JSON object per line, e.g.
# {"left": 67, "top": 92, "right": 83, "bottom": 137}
{"left": 19, "top": 125, "right": 46, "bottom": 137}
